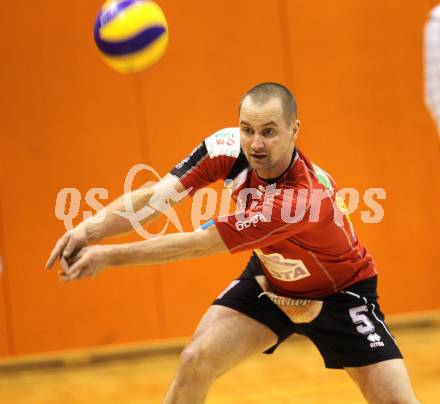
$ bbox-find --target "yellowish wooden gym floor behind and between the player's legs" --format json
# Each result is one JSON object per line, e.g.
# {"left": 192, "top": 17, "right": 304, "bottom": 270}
{"left": 0, "top": 322, "right": 440, "bottom": 404}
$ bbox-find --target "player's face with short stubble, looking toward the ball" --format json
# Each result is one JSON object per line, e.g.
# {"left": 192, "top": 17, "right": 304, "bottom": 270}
{"left": 240, "top": 97, "right": 300, "bottom": 178}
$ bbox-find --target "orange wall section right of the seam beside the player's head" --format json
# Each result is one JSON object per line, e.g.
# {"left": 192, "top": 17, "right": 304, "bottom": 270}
{"left": 287, "top": 0, "right": 440, "bottom": 312}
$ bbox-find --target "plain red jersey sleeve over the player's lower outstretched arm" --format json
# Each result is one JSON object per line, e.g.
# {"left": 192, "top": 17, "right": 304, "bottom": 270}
{"left": 214, "top": 185, "right": 326, "bottom": 253}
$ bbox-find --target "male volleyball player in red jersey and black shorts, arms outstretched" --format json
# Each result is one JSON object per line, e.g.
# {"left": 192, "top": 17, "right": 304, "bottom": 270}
{"left": 47, "top": 83, "right": 417, "bottom": 404}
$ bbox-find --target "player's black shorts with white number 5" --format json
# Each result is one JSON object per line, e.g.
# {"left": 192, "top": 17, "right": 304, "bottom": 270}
{"left": 213, "top": 255, "right": 402, "bottom": 369}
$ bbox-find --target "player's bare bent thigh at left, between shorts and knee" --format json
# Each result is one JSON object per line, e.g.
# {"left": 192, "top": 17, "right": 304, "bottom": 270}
{"left": 185, "top": 305, "right": 277, "bottom": 374}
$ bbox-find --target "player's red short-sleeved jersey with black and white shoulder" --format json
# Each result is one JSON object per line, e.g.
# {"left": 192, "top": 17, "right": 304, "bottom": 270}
{"left": 171, "top": 128, "right": 376, "bottom": 299}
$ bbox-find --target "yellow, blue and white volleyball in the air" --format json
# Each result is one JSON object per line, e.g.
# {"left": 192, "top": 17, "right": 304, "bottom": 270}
{"left": 94, "top": 0, "right": 168, "bottom": 73}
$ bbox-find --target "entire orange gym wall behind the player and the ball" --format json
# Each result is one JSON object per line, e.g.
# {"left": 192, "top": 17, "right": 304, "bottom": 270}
{"left": 0, "top": 0, "right": 440, "bottom": 355}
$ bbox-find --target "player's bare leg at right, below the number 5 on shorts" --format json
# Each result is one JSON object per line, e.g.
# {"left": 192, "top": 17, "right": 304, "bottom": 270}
{"left": 346, "top": 359, "right": 417, "bottom": 403}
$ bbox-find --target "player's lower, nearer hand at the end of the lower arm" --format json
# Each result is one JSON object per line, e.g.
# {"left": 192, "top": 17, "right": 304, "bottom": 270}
{"left": 59, "top": 245, "right": 110, "bottom": 282}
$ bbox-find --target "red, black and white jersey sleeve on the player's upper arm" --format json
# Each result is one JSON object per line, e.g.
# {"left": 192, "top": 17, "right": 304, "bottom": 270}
{"left": 170, "top": 128, "right": 240, "bottom": 196}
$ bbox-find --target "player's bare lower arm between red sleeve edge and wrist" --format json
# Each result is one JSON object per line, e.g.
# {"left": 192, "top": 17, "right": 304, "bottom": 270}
{"left": 106, "top": 232, "right": 226, "bottom": 266}
